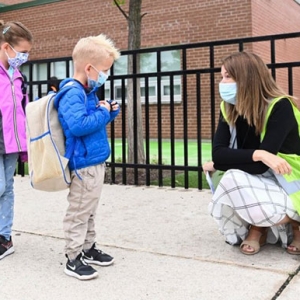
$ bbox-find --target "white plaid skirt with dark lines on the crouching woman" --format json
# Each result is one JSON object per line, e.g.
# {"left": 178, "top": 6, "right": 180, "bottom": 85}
{"left": 208, "top": 170, "right": 300, "bottom": 248}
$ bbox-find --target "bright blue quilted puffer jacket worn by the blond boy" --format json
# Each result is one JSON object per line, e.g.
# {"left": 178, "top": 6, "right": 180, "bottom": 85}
{"left": 54, "top": 78, "right": 120, "bottom": 171}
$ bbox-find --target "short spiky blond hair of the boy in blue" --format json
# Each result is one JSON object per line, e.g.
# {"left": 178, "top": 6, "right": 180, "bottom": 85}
{"left": 72, "top": 34, "right": 120, "bottom": 64}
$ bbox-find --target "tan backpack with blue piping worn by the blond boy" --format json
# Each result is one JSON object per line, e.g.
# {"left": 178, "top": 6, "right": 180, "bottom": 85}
{"left": 26, "top": 81, "right": 81, "bottom": 192}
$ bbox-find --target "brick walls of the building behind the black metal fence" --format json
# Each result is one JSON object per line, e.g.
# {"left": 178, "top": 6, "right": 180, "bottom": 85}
{"left": 0, "top": 0, "right": 300, "bottom": 138}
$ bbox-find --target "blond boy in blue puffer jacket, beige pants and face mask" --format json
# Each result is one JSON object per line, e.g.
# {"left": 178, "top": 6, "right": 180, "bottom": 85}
{"left": 54, "top": 34, "right": 120, "bottom": 280}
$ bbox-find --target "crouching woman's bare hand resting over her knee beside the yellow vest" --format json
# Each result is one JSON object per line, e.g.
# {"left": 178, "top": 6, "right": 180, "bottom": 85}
{"left": 252, "top": 150, "right": 292, "bottom": 175}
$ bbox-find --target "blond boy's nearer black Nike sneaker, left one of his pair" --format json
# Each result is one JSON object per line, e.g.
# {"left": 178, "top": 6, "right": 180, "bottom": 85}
{"left": 65, "top": 253, "right": 98, "bottom": 280}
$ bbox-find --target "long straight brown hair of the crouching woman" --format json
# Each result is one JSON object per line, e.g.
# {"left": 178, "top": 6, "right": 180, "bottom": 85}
{"left": 222, "top": 52, "right": 293, "bottom": 134}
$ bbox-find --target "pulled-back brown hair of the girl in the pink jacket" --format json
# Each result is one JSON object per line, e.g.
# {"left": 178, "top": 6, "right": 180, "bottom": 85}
{"left": 0, "top": 20, "right": 33, "bottom": 46}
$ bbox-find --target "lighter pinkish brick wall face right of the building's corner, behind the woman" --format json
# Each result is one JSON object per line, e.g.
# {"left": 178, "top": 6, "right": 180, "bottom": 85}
{"left": 251, "top": 0, "right": 300, "bottom": 104}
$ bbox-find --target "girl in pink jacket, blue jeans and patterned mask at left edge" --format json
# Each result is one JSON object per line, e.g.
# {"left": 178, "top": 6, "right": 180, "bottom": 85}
{"left": 0, "top": 21, "right": 33, "bottom": 260}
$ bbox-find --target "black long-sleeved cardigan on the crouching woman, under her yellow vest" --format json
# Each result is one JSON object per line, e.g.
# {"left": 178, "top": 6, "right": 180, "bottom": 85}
{"left": 212, "top": 98, "right": 300, "bottom": 174}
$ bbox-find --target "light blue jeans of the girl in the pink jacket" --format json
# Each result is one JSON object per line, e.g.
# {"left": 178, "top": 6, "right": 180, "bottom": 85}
{"left": 0, "top": 153, "right": 19, "bottom": 240}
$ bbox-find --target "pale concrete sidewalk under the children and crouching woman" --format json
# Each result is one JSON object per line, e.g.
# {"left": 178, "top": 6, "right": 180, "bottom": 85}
{"left": 0, "top": 177, "right": 300, "bottom": 300}
